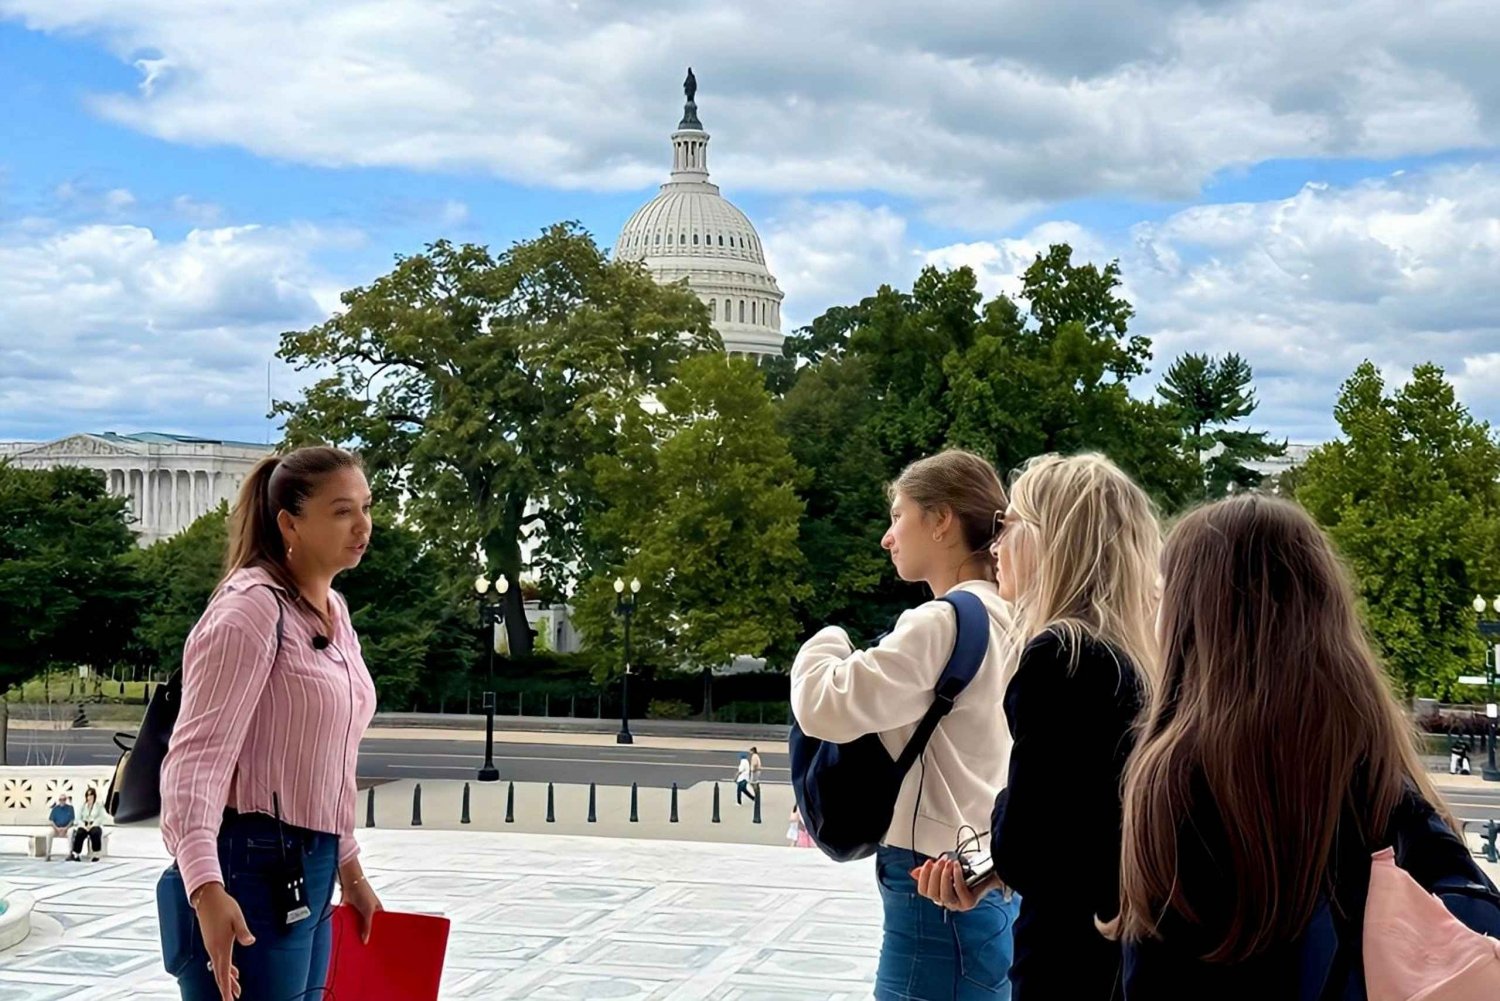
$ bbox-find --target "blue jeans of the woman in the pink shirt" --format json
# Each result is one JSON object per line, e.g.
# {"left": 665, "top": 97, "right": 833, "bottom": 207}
{"left": 156, "top": 810, "right": 339, "bottom": 1001}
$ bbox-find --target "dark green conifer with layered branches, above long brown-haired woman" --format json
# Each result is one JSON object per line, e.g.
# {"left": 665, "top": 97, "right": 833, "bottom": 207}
{"left": 1157, "top": 353, "right": 1287, "bottom": 497}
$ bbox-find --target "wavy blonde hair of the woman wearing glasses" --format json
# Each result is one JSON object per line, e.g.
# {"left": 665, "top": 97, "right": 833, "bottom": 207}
{"left": 1002, "top": 453, "right": 1161, "bottom": 690}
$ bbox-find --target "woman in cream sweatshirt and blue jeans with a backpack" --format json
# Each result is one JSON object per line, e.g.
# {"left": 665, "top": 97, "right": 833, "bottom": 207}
{"left": 792, "top": 450, "right": 1026, "bottom": 1001}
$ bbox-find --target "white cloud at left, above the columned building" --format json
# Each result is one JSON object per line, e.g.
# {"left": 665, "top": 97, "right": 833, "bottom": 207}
{"left": 0, "top": 219, "right": 338, "bottom": 437}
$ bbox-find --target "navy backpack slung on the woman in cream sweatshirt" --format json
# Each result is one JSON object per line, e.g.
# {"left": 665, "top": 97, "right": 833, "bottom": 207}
{"left": 789, "top": 590, "right": 999, "bottom": 861}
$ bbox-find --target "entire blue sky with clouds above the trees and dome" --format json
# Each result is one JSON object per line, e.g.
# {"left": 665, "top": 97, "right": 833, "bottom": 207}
{"left": 0, "top": 0, "right": 1500, "bottom": 441}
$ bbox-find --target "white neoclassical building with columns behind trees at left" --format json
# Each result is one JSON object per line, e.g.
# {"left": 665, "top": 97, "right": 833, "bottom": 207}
{"left": 0, "top": 431, "right": 272, "bottom": 546}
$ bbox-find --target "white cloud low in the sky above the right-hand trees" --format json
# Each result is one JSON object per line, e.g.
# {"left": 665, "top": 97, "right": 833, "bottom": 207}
{"left": 926, "top": 167, "right": 1500, "bottom": 440}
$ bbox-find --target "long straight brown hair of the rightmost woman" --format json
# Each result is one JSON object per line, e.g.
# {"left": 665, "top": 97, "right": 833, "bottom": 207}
{"left": 1113, "top": 494, "right": 1443, "bottom": 962}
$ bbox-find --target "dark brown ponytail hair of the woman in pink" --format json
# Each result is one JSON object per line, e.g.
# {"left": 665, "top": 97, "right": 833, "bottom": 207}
{"left": 219, "top": 446, "right": 362, "bottom": 626}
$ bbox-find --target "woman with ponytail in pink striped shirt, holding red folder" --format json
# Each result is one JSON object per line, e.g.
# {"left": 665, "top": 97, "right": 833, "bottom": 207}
{"left": 156, "top": 447, "right": 380, "bottom": 1001}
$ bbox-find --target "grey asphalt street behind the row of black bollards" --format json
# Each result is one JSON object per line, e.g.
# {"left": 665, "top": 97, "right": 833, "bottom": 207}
{"left": 9, "top": 729, "right": 798, "bottom": 792}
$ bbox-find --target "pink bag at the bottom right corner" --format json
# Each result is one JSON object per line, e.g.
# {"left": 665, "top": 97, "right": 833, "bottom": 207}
{"left": 1364, "top": 848, "right": 1500, "bottom": 1001}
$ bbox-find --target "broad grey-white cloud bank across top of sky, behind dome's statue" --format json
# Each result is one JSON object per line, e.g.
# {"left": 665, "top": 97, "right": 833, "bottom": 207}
{"left": 0, "top": 0, "right": 1500, "bottom": 225}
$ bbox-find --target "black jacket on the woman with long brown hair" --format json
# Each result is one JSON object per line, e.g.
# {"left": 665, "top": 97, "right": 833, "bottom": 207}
{"left": 1125, "top": 779, "right": 1500, "bottom": 1001}
